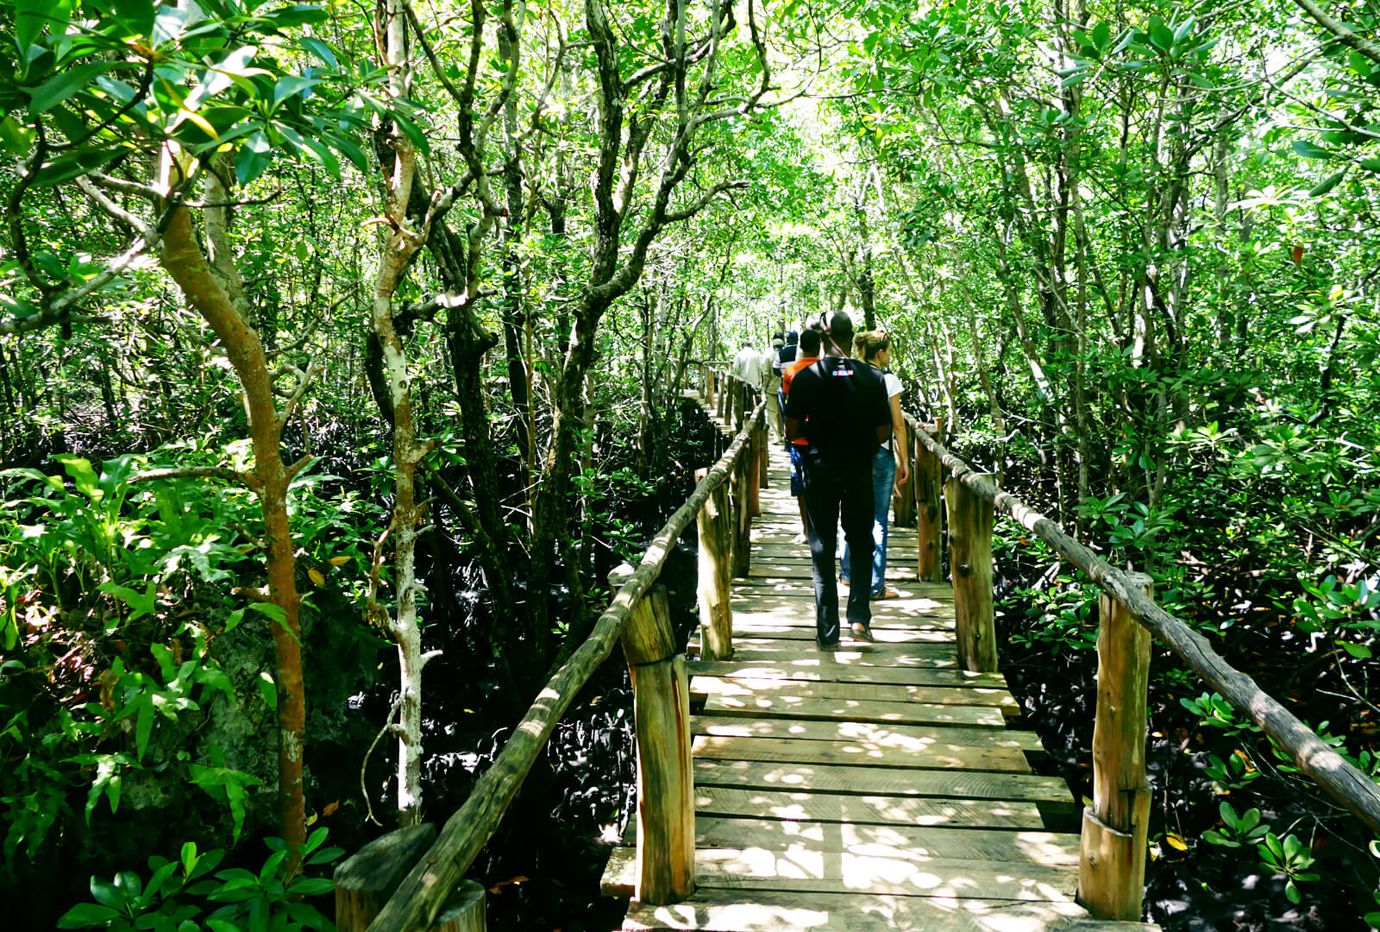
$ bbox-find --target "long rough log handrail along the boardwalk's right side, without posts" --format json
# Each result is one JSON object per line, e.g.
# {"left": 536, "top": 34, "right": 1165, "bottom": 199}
{"left": 908, "top": 416, "right": 1380, "bottom": 831}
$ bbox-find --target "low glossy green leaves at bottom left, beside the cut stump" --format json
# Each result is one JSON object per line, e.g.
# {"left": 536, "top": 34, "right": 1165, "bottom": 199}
{"left": 58, "top": 828, "right": 344, "bottom": 932}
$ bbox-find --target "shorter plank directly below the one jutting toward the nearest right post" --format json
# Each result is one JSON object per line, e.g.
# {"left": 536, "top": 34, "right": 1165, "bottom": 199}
{"left": 696, "top": 786, "right": 1045, "bottom": 828}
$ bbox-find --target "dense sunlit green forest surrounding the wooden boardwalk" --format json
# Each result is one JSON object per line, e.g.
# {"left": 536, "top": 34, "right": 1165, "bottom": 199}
{"left": 0, "top": 0, "right": 1380, "bottom": 928}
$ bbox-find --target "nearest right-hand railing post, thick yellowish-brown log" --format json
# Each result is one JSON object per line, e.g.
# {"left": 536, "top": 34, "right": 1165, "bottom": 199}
{"left": 1078, "top": 573, "right": 1152, "bottom": 921}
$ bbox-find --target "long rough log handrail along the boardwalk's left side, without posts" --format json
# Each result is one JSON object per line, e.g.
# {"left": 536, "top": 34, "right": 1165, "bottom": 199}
{"left": 368, "top": 383, "right": 766, "bottom": 932}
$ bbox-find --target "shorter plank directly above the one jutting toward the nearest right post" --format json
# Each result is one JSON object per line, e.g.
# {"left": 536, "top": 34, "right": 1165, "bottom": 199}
{"left": 691, "top": 735, "right": 1031, "bottom": 773}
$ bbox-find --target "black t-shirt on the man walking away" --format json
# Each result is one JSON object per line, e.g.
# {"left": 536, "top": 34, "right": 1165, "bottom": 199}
{"left": 785, "top": 356, "right": 891, "bottom": 461}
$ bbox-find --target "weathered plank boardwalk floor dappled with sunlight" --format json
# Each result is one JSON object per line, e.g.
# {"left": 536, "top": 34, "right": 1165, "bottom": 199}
{"left": 604, "top": 419, "right": 1152, "bottom": 932}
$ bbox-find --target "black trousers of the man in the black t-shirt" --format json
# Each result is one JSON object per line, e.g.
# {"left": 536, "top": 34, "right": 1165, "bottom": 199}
{"left": 805, "top": 453, "right": 872, "bottom": 645}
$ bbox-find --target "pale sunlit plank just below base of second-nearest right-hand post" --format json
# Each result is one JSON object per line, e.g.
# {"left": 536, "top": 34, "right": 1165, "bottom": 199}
{"left": 690, "top": 674, "right": 1018, "bottom": 712}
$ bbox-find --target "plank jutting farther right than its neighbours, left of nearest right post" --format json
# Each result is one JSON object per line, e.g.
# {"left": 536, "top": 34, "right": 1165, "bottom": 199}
{"left": 694, "top": 759, "right": 1078, "bottom": 806}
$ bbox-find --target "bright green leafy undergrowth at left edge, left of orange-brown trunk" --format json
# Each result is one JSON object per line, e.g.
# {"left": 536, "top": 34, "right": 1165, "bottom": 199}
{"left": 0, "top": 456, "right": 277, "bottom": 864}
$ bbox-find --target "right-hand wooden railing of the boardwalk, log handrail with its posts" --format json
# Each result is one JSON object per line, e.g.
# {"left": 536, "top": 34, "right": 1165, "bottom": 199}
{"left": 907, "top": 416, "right": 1380, "bottom": 920}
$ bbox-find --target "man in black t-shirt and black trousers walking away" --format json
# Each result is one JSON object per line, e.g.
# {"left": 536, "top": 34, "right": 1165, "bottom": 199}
{"left": 785, "top": 312, "right": 891, "bottom": 650}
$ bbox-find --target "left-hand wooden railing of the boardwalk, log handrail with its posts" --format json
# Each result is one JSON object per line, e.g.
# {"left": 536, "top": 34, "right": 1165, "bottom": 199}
{"left": 335, "top": 365, "right": 767, "bottom": 932}
